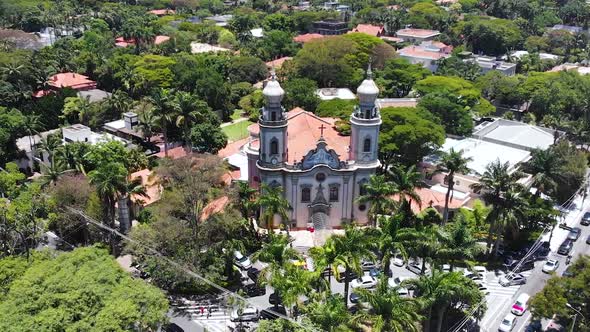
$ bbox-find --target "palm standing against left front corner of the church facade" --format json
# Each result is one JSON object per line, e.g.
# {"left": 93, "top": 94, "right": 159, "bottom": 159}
{"left": 258, "top": 183, "right": 291, "bottom": 236}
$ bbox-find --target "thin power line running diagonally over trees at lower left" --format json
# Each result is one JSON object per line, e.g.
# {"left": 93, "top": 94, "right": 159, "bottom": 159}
{"left": 66, "top": 206, "right": 315, "bottom": 331}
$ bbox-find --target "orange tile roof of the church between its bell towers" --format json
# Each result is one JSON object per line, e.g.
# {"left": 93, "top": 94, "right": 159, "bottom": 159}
{"left": 248, "top": 107, "right": 350, "bottom": 162}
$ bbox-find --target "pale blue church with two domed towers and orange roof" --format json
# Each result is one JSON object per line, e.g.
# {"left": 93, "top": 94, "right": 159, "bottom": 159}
{"left": 244, "top": 70, "right": 381, "bottom": 229}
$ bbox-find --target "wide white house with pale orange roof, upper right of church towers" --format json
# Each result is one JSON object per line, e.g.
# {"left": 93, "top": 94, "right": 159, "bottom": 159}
{"left": 397, "top": 41, "right": 453, "bottom": 73}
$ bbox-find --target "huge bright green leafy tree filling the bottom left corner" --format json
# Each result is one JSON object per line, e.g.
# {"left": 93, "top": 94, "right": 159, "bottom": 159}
{"left": 0, "top": 247, "right": 168, "bottom": 331}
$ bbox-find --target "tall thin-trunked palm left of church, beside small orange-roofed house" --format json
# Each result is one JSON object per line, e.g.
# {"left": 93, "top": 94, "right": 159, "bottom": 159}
{"left": 88, "top": 162, "right": 128, "bottom": 255}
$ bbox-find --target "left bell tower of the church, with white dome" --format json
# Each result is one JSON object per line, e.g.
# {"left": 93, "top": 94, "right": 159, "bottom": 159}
{"left": 258, "top": 69, "right": 288, "bottom": 167}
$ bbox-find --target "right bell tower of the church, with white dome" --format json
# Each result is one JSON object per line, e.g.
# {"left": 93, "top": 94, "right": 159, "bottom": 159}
{"left": 350, "top": 65, "right": 381, "bottom": 164}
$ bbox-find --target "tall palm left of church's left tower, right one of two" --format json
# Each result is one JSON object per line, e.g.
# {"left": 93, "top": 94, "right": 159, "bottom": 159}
{"left": 174, "top": 91, "right": 209, "bottom": 152}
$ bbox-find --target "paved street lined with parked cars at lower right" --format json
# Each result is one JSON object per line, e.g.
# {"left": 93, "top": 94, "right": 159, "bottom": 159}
{"left": 480, "top": 192, "right": 590, "bottom": 332}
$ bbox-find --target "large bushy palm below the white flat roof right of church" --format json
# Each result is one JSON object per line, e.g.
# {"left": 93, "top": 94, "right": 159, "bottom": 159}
{"left": 471, "top": 160, "right": 523, "bottom": 255}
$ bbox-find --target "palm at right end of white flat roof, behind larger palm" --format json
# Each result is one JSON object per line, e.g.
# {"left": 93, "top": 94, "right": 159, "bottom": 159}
{"left": 523, "top": 149, "right": 561, "bottom": 197}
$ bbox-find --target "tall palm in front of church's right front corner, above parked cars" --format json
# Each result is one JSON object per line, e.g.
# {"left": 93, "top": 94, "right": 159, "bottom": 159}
{"left": 328, "top": 226, "right": 375, "bottom": 305}
